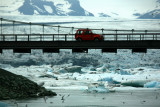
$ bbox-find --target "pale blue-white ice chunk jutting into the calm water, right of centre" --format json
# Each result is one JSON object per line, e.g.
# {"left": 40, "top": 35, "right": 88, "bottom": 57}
{"left": 87, "top": 84, "right": 109, "bottom": 93}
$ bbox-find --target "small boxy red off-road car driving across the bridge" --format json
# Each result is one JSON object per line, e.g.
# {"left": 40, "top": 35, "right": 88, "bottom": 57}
{"left": 75, "top": 29, "right": 104, "bottom": 41}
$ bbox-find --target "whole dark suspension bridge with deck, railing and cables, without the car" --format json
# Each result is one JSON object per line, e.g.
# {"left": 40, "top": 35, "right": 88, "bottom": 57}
{"left": 0, "top": 18, "right": 160, "bottom": 53}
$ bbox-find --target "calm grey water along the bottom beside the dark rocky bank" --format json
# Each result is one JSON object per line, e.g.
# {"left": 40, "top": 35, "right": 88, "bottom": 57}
{"left": 4, "top": 90, "right": 160, "bottom": 107}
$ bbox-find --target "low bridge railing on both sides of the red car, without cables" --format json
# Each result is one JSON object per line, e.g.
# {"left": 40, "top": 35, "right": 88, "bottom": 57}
{"left": 0, "top": 33, "right": 160, "bottom": 41}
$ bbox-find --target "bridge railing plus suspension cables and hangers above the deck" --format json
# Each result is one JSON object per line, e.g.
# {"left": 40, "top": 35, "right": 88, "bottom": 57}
{"left": 0, "top": 18, "right": 160, "bottom": 41}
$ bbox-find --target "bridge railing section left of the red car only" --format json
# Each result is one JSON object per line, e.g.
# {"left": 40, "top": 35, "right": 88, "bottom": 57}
{"left": 0, "top": 34, "right": 76, "bottom": 41}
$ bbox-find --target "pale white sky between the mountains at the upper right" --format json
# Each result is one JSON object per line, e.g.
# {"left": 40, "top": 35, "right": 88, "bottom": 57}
{"left": 80, "top": 0, "right": 156, "bottom": 15}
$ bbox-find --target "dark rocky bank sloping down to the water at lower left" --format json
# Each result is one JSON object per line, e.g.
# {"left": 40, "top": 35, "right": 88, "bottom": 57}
{"left": 0, "top": 69, "right": 56, "bottom": 100}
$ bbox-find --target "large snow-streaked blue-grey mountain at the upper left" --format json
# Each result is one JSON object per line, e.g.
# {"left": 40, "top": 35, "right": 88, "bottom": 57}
{"left": 0, "top": 0, "right": 93, "bottom": 16}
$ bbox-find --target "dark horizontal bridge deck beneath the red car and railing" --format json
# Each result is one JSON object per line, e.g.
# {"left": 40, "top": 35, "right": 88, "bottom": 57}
{"left": 0, "top": 40, "right": 160, "bottom": 49}
